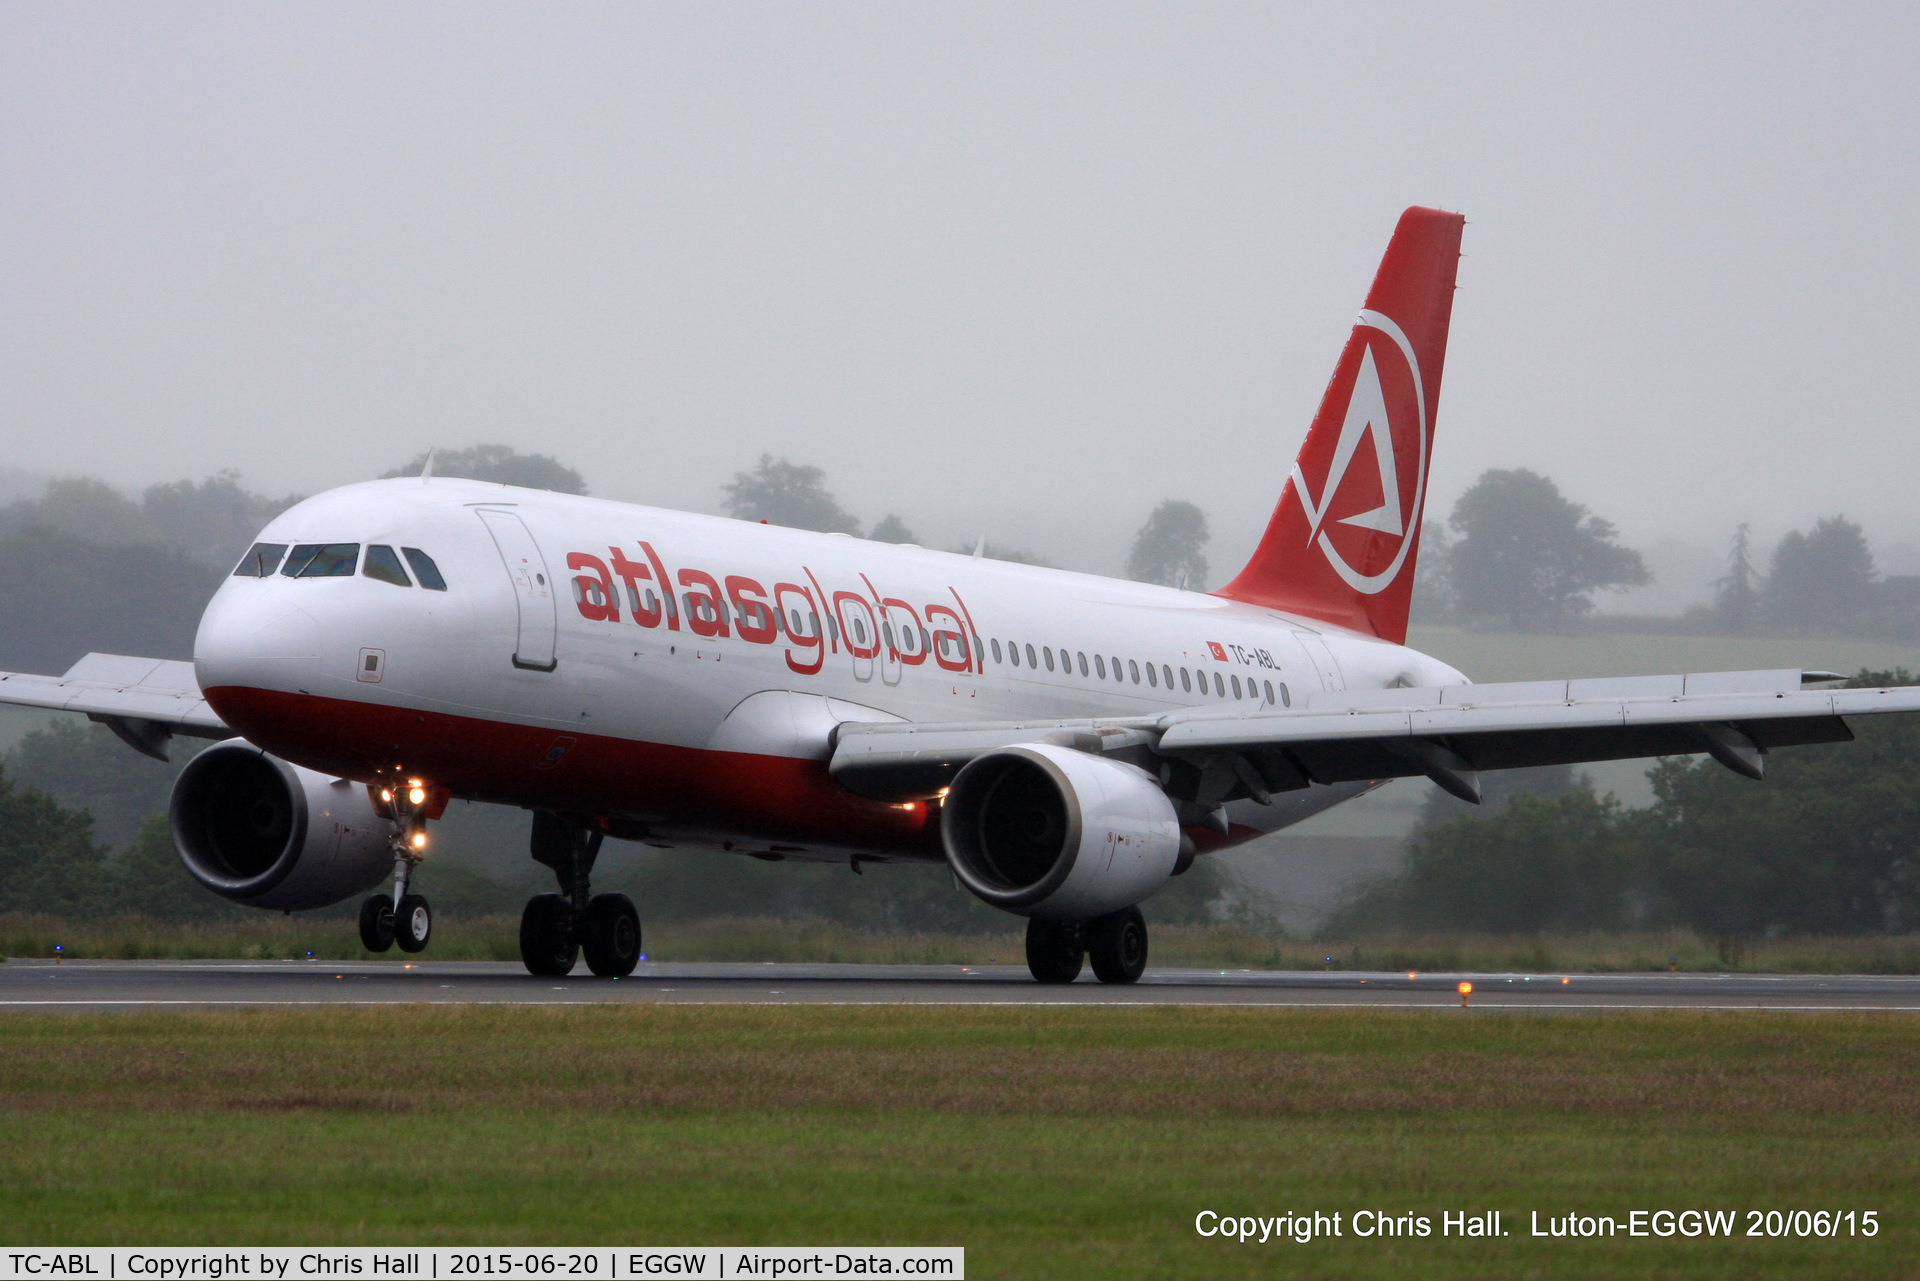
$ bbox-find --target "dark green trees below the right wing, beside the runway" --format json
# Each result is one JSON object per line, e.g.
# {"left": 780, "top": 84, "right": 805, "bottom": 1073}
{"left": 1323, "top": 670, "right": 1920, "bottom": 939}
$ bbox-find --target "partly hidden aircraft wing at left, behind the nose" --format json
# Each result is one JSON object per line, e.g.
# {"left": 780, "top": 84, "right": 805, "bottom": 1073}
{"left": 0, "top": 653, "right": 232, "bottom": 761}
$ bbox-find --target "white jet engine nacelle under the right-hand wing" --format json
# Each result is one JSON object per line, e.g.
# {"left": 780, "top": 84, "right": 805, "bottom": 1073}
{"left": 941, "top": 743, "right": 1181, "bottom": 920}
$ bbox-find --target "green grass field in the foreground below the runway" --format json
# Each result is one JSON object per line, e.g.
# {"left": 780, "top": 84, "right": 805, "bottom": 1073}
{"left": 0, "top": 1006, "right": 1920, "bottom": 1277}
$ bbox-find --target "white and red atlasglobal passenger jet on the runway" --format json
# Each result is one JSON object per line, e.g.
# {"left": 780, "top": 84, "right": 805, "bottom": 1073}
{"left": 0, "top": 209, "right": 1920, "bottom": 983}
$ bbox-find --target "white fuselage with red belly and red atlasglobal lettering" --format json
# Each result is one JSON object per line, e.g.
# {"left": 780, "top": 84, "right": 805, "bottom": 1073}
{"left": 194, "top": 478, "right": 1465, "bottom": 858}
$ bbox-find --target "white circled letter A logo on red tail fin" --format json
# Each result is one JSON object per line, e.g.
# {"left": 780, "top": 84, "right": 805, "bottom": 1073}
{"left": 1292, "top": 311, "right": 1427, "bottom": 595}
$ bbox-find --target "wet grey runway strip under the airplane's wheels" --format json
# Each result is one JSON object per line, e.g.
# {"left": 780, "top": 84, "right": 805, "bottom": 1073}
{"left": 0, "top": 960, "right": 1920, "bottom": 1012}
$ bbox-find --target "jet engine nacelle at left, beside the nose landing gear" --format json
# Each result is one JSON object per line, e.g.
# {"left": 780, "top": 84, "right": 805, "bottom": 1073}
{"left": 167, "top": 737, "right": 394, "bottom": 910}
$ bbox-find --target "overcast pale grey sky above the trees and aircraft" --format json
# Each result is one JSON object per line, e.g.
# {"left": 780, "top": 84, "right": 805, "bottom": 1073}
{"left": 0, "top": 2, "right": 1920, "bottom": 580}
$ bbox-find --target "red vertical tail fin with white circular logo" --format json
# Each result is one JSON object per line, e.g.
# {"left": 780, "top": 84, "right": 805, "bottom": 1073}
{"left": 1215, "top": 207, "right": 1467, "bottom": 643}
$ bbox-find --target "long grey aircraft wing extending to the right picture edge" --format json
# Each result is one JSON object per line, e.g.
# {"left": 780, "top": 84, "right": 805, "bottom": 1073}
{"left": 829, "top": 670, "right": 1920, "bottom": 803}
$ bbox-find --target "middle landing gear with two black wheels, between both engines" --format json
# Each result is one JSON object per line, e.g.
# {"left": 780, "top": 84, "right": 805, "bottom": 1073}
{"left": 520, "top": 810, "right": 639, "bottom": 978}
